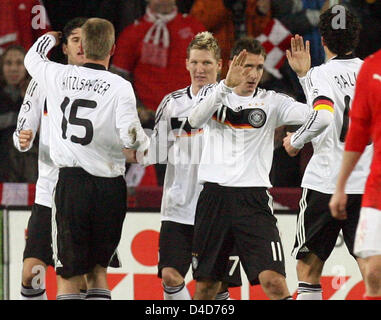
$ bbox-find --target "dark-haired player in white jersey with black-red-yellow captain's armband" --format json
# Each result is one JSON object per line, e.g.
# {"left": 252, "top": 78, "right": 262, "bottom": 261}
{"left": 284, "top": 6, "right": 372, "bottom": 300}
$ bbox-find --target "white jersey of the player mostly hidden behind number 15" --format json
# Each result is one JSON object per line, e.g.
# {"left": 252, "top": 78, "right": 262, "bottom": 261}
{"left": 13, "top": 79, "right": 58, "bottom": 208}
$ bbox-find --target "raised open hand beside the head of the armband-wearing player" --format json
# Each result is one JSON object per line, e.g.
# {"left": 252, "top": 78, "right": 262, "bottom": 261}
{"left": 286, "top": 34, "right": 311, "bottom": 77}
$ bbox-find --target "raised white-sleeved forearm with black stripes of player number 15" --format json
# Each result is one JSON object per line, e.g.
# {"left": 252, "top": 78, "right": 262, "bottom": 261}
{"left": 24, "top": 34, "right": 56, "bottom": 79}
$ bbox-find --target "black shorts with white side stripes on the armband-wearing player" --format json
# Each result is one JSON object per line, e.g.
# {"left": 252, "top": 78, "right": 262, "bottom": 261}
{"left": 292, "top": 189, "right": 362, "bottom": 261}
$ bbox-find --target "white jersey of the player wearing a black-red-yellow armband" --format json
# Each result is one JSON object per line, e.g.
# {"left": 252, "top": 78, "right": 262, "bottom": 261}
{"left": 295, "top": 56, "right": 373, "bottom": 194}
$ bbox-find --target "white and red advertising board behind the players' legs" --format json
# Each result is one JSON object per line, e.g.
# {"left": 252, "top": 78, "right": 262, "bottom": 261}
{"left": 0, "top": 183, "right": 364, "bottom": 300}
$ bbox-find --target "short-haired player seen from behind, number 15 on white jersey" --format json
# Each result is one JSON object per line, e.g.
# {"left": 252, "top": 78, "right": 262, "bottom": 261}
{"left": 25, "top": 18, "right": 149, "bottom": 300}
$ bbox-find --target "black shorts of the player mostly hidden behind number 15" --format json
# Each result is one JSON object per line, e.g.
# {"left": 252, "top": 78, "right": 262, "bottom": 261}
{"left": 23, "top": 203, "right": 54, "bottom": 266}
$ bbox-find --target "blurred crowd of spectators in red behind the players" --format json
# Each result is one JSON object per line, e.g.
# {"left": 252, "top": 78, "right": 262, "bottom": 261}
{"left": 0, "top": 0, "right": 381, "bottom": 187}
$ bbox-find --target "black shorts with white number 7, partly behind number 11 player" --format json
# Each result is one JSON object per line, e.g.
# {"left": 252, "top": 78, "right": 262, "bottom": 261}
{"left": 158, "top": 221, "right": 242, "bottom": 287}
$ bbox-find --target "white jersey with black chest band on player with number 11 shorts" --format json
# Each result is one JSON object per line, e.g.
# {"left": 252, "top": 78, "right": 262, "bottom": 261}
{"left": 190, "top": 81, "right": 311, "bottom": 188}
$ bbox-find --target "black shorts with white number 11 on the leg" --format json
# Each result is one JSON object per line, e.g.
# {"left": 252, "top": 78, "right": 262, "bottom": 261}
{"left": 192, "top": 183, "right": 286, "bottom": 285}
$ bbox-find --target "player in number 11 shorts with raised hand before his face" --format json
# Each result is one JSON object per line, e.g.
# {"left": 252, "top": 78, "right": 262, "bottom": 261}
{"left": 188, "top": 38, "right": 310, "bottom": 300}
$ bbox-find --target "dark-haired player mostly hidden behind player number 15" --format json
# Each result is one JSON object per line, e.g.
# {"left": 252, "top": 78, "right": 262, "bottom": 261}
{"left": 13, "top": 18, "right": 86, "bottom": 300}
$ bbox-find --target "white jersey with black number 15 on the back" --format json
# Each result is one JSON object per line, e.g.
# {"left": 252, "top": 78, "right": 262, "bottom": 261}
{"left": 25, "top": 35, "right": 142, "bottom": 177}
